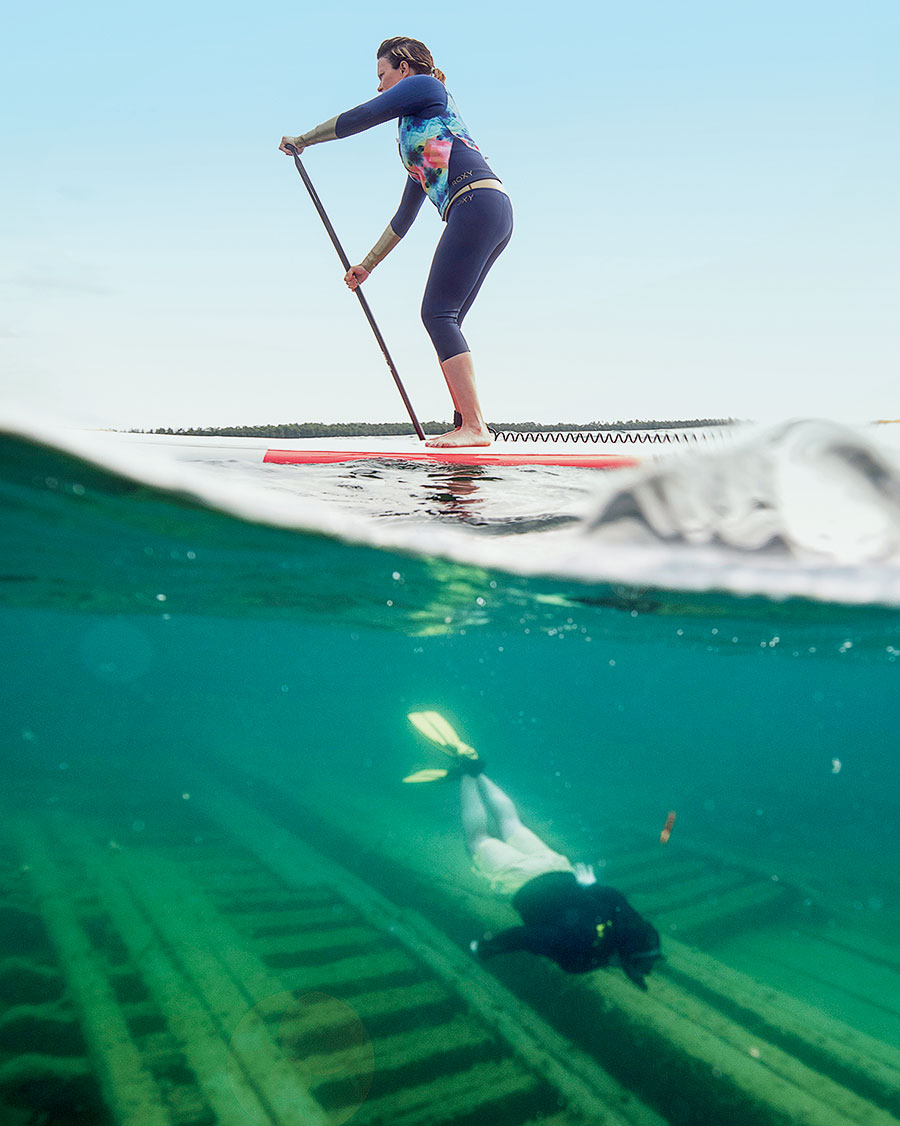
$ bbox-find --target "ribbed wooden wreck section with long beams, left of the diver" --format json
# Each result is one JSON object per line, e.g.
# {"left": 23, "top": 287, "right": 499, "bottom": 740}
{"left": 0, "top": 793, "right": 663, "bottom": 1126}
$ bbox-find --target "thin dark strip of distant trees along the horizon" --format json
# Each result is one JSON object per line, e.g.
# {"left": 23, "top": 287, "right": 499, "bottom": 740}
{"left": 128, "top": 419, "right": 739, "bottom": 438}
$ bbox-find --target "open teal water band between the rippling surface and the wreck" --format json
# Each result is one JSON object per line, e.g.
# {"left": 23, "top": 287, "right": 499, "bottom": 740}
{"left": 3, "top": 607, "right": 900, "bottom": 900}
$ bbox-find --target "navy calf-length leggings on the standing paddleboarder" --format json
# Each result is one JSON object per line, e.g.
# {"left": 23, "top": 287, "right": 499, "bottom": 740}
{"left": 422, "top": 188, "right": 513, "bottom": 364}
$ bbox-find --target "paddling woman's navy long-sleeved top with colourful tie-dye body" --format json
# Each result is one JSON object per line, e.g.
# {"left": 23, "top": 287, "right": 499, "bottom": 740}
{"left": 335, "top": 74, "right": 498, "bottom": 238}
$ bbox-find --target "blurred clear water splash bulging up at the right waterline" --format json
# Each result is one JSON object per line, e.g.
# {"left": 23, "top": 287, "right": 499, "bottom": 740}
{"left": 587, "top": 421, "right": 900, "bottom": 565}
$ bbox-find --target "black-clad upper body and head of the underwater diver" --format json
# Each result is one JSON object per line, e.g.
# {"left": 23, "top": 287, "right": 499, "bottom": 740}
{"left": 475, "top": 872, "right": 660, "bottom": 989}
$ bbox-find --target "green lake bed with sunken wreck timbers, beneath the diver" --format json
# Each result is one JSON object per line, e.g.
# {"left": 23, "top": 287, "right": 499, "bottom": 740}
{"left": 0, "top": 757, "right": 900, "bottom": 1126}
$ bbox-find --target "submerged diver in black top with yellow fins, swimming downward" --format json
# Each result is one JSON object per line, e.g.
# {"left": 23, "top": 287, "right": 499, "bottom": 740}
{"left": 403, "top": 712, "right": 662, "bottom": 990}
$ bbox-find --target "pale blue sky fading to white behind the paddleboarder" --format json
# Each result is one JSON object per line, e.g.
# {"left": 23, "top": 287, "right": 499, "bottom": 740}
{"left": 0, "top": 0, "right": 900, "bottom": 429}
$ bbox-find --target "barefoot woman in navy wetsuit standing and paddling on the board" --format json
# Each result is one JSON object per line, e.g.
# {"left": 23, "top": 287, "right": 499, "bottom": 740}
{"left": 279, "top": 36, "right": 513, "bottom": 447}
